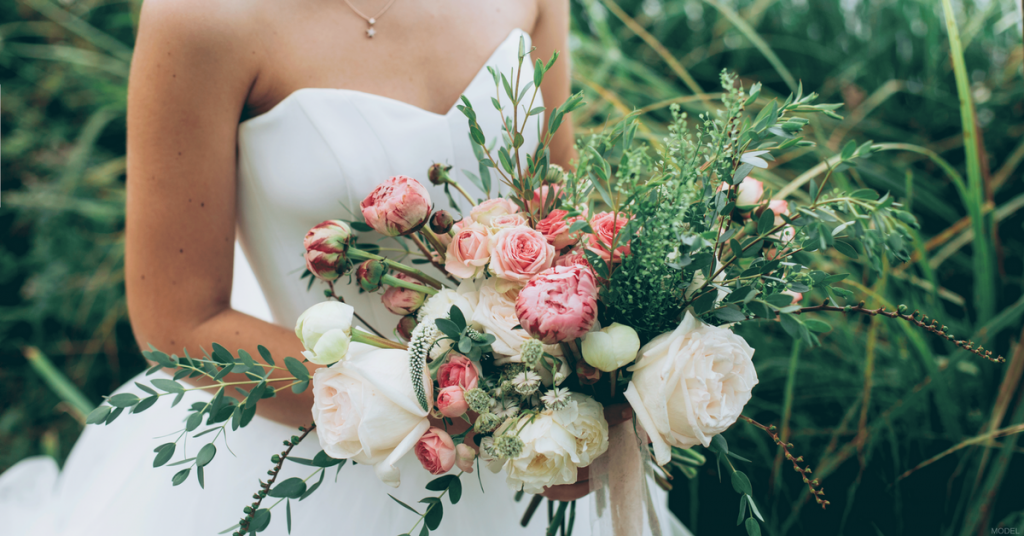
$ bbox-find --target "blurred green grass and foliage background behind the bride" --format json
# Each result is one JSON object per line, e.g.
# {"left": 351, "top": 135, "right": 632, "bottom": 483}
{"left": 0, "top": 0, "right": 1024, "bottom": 536}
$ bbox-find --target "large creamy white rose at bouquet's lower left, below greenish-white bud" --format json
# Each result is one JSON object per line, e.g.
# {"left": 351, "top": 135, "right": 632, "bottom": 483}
{"left": 312, "top": 349, "right": 433, "bottom": 487}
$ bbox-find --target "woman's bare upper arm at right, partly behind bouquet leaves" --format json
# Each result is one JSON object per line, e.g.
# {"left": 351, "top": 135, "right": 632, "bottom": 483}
{"left": 530, "top": 0, "right": 577, "bottom": 169}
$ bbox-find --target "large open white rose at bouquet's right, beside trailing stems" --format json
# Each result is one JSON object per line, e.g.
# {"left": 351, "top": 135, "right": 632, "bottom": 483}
{"left": 626, "top": 312, "right": 758, "bottom": 465}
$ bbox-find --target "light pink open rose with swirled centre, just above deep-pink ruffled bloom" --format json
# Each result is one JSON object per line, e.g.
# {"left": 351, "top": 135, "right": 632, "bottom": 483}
{"left": 489, "top": 225, "right": 555, "bottom": 283}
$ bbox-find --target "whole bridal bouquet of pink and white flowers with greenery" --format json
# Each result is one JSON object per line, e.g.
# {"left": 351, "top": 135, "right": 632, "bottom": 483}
{"left": 89, "top": 39, "right": 998, "bottom": 535}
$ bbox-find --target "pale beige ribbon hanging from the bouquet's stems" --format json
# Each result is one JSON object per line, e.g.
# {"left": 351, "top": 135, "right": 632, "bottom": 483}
{"left": 590, "top": 421, "right": 662, "bottom": 536}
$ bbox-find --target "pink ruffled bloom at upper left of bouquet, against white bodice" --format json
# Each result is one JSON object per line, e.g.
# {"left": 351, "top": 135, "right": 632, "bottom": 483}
{"left": 359, "top": 175, "right": 430, "bottom": 237}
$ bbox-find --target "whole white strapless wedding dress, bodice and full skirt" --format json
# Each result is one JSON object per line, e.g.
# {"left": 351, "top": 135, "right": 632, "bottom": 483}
{"left": 0, "top": 30, "right": 688, "bottom": 536}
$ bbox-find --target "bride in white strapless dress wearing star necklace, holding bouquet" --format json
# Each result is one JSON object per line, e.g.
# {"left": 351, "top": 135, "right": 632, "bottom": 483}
{"left": 0, "top": 0, "right": 686, "bottom": 536}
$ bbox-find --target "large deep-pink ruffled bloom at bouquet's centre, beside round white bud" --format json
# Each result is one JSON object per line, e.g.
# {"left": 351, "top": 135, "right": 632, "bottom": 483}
{"left": 515, "top": 266, "right": 597, "bottom": 344}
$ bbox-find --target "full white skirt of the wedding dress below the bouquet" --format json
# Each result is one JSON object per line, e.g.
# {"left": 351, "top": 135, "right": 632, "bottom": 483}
{"left": 0, "top": 372, "right": 689, "bottom": 536}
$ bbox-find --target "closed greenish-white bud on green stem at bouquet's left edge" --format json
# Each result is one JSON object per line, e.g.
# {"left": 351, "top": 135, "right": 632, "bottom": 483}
{"left": 295, "top": 301, "right": 355, "bottom": 365}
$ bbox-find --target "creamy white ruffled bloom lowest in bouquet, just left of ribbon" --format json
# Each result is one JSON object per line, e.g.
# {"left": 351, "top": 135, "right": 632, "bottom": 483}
{"left": 505, "top": 413, "right": 580, "bottom": 493}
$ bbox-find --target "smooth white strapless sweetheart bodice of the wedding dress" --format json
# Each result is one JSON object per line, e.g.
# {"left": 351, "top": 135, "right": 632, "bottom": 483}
{"left": 231, "top": 30, "right": 543, "bottom": 333}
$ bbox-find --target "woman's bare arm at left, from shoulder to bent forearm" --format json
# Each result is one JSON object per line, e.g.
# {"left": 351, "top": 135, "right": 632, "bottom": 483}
{"left": 125, "top": 0, "right": 312, "bottom": 425}
